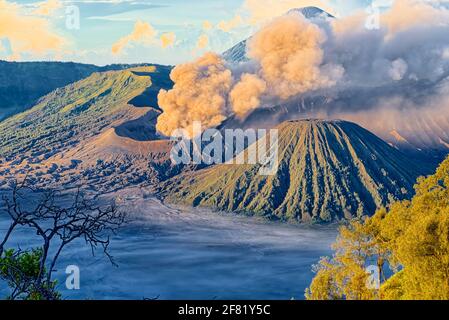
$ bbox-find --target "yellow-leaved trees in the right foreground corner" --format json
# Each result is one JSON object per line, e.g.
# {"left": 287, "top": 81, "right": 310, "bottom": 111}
{"left": 306, "top": 158, "right": 449, "bottom": 300}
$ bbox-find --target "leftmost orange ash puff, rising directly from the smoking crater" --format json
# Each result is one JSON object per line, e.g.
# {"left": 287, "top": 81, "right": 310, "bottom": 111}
{"left": 156, "top": 53, "right": 233, "bottom": 136}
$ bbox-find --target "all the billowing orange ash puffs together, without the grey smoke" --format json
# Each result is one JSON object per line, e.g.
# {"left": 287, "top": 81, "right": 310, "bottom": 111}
{"left": 157, "top": 13, "right": 343, "bottom": 135}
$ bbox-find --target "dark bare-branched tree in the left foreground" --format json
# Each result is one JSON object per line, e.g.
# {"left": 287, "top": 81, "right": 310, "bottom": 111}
{"left": 0, "top": 179, "right": 126, "bottom": 300}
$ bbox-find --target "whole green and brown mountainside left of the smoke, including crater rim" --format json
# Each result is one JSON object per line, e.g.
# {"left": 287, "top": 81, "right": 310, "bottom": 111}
{"left": 0, "top": 66, "right": 178, "bottom": 190}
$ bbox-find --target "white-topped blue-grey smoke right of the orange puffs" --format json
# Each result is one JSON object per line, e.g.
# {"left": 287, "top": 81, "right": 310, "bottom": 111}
{"left": 323, "top": 0, "right": 449, "bottom": 86}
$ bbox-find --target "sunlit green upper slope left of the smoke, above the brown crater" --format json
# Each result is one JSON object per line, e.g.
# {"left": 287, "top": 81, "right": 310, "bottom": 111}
{"left": 0, "top": 67, "right": 170, "bottom": 162}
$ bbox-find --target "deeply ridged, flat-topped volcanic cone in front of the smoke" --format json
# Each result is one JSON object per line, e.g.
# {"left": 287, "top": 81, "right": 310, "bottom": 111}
{"left": 162, "top": 120, "right": 426, "bottom": 222}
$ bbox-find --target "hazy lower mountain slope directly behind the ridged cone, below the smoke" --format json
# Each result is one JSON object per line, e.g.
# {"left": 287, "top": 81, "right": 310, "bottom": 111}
{"left": 222, "top": 84, "right": 449, "bottom": 164}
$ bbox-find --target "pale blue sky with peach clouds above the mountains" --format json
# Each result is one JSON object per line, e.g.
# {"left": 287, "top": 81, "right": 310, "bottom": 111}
{"left": 0, "top": 0, "right": 378, "bottom": 65}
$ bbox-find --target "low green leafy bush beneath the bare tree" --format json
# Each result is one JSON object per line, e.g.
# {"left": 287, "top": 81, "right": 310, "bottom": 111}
{"left": 0, "top": 248, "right": 61, "bottom": 300}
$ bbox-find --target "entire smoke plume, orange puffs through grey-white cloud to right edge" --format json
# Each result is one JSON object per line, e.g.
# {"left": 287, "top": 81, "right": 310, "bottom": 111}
{"left": 157, "top": 0, "right": 449, "bottom": 146}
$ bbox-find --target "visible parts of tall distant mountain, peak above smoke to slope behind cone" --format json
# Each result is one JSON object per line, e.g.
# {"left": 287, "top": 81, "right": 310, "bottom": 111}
{"left": 223, "top": 7, "right": 449, "bottom": 162}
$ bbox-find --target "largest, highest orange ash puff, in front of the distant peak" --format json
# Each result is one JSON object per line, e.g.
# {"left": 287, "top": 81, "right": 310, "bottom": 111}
{"left": 248, "top": 13, "right": 343, "bottom": 100}
